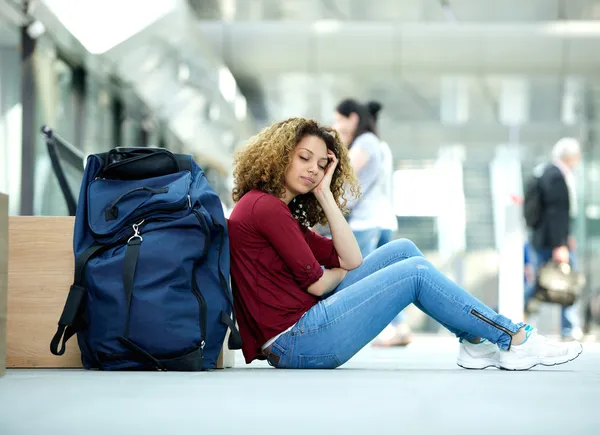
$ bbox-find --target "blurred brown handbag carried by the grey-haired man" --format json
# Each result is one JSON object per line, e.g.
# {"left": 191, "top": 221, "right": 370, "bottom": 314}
{"left": 535, "top": 260, "right": 585, "bottom": 306}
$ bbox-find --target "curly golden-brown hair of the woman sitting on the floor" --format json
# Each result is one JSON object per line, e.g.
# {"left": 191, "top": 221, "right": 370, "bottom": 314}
{"left": 232, "top": 118, "right": 360, "bottom": 227}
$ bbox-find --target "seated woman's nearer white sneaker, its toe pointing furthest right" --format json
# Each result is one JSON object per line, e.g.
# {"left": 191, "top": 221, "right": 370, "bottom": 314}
{"left": 498, "top": 325, "right": 583, "bottom": 370}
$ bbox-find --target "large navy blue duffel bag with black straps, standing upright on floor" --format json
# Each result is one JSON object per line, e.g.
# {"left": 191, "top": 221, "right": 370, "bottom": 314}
{"left": 50, "top": 148, "right": 241, "bottom": 371}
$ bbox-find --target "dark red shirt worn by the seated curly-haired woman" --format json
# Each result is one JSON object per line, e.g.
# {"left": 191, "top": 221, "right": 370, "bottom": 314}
{"left": 228, "top": 190, "right": 340, "bottom": 363}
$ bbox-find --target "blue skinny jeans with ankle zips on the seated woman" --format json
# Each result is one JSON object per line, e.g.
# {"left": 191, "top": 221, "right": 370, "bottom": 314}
{"left": 269, "top": 239, "right": 523, "bottom": 369}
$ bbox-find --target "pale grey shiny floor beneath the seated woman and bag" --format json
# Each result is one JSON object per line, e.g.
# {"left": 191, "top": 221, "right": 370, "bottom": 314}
{"left": 0, "top": 336, "right": 600, "bottom": 435}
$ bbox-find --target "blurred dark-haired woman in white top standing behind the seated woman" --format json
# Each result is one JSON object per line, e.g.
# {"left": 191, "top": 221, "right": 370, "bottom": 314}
{"left": 334, "top": 99, "right": 383, "bottom": 257}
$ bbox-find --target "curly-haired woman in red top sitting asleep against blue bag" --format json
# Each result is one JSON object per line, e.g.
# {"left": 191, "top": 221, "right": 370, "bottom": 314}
{"left": 229, "top": 118, "right": 582, "bottom": 370}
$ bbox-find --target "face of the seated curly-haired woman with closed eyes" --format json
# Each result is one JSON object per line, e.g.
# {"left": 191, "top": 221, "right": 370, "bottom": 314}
{"left": 285, "top": 135, "right": 329, "bottom": 199}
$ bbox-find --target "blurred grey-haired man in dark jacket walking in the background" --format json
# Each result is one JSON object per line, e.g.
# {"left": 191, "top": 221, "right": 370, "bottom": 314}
{"left": 531, "top": 138, "right": 582, "bottom": 340}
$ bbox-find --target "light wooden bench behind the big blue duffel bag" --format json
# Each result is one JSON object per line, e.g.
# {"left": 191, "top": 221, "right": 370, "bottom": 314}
{"left": 7, "top": 216, "right": 235, "bottom": 368}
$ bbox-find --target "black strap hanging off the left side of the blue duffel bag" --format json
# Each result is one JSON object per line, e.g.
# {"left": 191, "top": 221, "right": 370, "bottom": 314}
{"left": 50, "top": 243, "right": 110, "bottom": 356}
